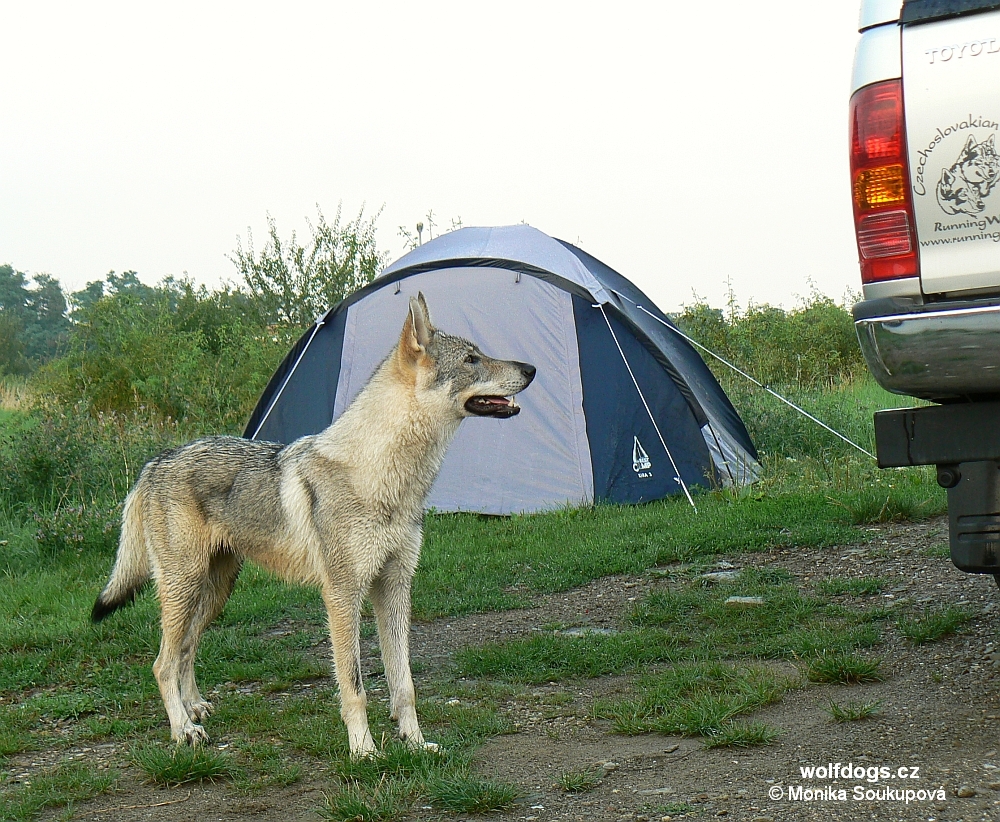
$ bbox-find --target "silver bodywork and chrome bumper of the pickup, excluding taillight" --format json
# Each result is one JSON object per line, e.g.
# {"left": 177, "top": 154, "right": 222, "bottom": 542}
{"left": 852, "top": 0, "right": 1000, "bottom": 400}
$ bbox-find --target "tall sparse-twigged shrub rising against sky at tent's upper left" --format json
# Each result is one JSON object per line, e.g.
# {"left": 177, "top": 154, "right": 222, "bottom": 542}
{"left": 229, "top": 205, "right": 386, "bottom": 327}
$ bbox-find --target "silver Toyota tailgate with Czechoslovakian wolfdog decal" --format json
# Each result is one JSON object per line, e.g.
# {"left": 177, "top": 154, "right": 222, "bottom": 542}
{"left": 902, "top": 11, "right": 1000, "bottom": 294}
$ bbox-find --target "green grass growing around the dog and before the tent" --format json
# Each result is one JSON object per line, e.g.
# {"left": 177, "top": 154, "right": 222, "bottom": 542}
{"left": 0, "top": 382, "right": 952, "bottom": 822}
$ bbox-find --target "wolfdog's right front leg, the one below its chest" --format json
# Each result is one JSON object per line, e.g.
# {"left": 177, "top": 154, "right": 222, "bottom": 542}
{"left": 369, "top": 559, "right": 433, "bottom": 747}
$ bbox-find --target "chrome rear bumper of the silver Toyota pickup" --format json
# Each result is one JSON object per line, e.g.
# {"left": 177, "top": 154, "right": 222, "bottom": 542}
{"left": 854, "top": 299, "right": 1000, "bottom": 400}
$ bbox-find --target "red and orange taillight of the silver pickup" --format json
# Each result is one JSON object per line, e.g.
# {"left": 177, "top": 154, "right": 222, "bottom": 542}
{"left": 851, "top": 80, "right": 919, "bottom": 283}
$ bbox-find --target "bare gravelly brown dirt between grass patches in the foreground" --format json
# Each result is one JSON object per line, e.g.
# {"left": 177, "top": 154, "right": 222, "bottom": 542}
{"left": 23, "top": 520, "right": 1000, "bottom": 822}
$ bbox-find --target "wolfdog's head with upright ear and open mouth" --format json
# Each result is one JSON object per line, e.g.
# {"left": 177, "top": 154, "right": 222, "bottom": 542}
{"left": 398, "top": 293, "right": 535, "bottom": 419}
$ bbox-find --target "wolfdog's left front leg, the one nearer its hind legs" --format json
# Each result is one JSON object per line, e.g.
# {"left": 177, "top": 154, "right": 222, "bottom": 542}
{"left": 323, "top": 584, "right": 375, "bottom": 758}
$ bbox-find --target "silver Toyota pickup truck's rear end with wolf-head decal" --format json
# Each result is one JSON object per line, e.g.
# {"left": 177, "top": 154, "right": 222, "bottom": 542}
{"left": 850, "top": 0, "right": 1000, "bottom": 585}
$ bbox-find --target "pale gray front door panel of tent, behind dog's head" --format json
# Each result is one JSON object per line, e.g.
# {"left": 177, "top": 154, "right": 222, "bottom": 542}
{"left": 333, "top": 268, "right": 594, "bottom": 514}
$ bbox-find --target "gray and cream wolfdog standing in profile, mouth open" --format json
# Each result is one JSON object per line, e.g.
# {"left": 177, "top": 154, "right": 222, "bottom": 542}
{"left": 92, "top": 294, "right": 535, "bottom": 756}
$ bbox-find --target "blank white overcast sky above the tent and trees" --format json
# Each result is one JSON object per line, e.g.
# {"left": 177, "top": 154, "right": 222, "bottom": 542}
{"left": 0, "top": 0, "right": 860, "bottom": 311}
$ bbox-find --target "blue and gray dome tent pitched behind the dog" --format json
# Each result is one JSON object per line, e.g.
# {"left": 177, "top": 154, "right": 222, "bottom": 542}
{"left": 245, "top": 225, "right": 759, "bottom": 514}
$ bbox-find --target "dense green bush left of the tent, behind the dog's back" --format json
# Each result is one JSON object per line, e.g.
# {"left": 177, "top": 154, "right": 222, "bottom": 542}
{"left": 36, "top": 281, "right": 286, "bottom": 433}
